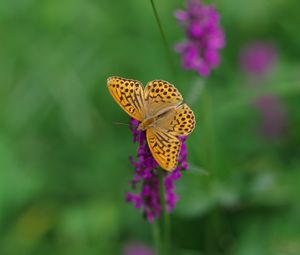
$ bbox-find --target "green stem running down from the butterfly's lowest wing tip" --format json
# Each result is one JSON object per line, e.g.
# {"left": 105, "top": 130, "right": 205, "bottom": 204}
{"left": 158, "top": 169, "right": 171, "bottom": 255}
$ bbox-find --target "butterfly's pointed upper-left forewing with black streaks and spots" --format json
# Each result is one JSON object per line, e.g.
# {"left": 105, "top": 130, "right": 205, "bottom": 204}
{"left": 107, "top": 77, "right": 145, "bottom": 121}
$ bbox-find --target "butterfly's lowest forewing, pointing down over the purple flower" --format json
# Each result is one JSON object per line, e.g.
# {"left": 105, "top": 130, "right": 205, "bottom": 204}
{"left": 146, "top": 128, "right": 181, "bottom": 171}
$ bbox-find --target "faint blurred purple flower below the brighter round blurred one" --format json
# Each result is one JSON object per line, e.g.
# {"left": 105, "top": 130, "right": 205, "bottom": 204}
{"left": 254, "top": 94, "right": 287, "bottom": 138}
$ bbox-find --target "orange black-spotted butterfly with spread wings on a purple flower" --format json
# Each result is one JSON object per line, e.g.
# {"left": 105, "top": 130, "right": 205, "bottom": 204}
{"left": 107, "top": 76, "right": 195, "bottom": 171}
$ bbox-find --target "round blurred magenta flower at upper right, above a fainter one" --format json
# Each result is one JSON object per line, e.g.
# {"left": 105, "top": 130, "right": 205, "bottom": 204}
{"left": 240, "top": 42, "right": 278, "bottom": 76}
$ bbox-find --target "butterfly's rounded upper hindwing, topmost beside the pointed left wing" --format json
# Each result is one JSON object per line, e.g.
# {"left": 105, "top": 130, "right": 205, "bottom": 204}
{"left": 144, "top": 80, "right": 183, "bottom": 117}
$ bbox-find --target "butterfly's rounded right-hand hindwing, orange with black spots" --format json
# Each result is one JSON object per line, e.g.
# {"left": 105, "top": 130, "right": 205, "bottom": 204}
{"left": 156, "top": 104, "right": 195, "bottom": 136}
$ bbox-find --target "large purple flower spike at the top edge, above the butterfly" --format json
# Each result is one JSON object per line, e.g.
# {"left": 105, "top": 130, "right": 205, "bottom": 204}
{"left": 175, "top": 0, "right": 225, "bottom": 76}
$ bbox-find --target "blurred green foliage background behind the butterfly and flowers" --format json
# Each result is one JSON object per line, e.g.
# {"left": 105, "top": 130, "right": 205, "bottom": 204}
{"left": 0, "top": 0, "right": 300, "bottom": 255}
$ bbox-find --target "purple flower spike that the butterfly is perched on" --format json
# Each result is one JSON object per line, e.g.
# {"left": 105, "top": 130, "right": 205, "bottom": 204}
{"left": 126, "top": 119, "right": 188, "bottom": 222}
